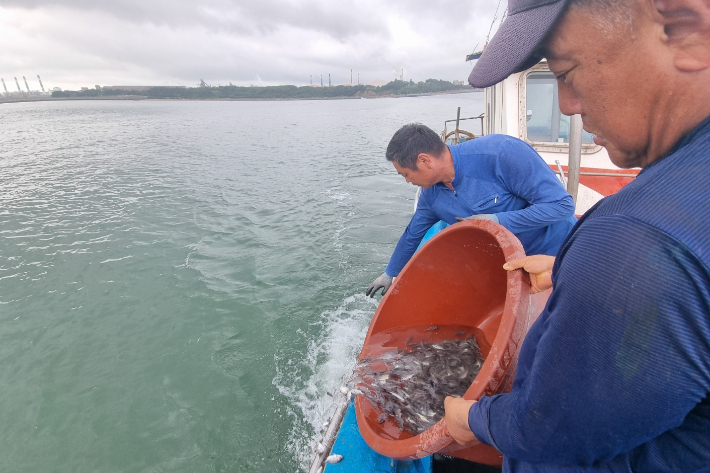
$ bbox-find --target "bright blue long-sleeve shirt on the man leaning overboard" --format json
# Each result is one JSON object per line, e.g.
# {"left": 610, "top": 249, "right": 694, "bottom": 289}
{"left": 385, "top": 135, "right": 577, "bottom": 276}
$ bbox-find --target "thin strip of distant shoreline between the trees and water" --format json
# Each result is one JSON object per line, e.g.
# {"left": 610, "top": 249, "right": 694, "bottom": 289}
{"left": 0, "top": 88, "right": 483, "bottom": 105}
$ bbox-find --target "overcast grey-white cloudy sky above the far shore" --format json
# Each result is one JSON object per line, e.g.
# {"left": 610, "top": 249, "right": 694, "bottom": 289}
{"left": 0, "top": 0, "right": 507, "bottom": 90}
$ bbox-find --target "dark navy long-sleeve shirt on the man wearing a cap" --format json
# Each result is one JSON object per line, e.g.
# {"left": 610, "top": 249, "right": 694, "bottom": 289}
{"left": 469, "top": 118, "right": 710, "bottom": 473}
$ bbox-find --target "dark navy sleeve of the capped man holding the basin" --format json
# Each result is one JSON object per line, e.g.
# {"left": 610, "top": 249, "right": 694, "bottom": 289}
{"left": 469, "top": 216, "right": 710, "bottom": 465}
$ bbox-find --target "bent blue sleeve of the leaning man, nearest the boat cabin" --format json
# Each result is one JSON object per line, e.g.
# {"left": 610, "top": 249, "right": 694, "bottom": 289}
{"left": 496, "top": 139, "right": 574, "bottom": 233}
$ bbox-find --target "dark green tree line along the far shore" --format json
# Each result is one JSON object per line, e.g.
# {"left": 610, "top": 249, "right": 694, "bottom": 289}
{"left": 52, "top": 79, "right": 470, "bottom": 99}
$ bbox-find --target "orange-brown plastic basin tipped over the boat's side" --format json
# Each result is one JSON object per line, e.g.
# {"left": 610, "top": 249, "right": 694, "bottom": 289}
{"left": 355, "top": 220, "right": 549, "bottom": 465}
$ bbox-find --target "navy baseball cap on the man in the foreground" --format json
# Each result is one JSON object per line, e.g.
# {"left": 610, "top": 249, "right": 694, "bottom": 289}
{"left": 468, "top": 0, "right": 569, "bottom": 88}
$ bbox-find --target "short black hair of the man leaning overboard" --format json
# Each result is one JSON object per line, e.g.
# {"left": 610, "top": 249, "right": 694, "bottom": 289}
{"left": 385, "top": 123, "right": 446, "bottom": 171}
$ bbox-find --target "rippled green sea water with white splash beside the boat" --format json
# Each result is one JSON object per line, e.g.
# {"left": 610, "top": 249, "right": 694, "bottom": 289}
{"left": 0, "top": 93, "right": 483, "bottom": 472}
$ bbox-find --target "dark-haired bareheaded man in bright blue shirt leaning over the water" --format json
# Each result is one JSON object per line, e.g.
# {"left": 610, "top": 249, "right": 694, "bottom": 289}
{"left": 366, "top": 124, "right": 577, "bottom": 297}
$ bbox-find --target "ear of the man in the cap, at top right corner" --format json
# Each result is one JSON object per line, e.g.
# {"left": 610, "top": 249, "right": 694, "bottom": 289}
{"left": 654, "top": 0, "right": 710, "bottom": 72}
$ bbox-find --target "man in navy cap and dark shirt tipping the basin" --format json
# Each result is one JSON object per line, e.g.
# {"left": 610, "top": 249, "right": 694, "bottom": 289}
{"left": 446, "top": 0, "right": 710, "bottom": 473}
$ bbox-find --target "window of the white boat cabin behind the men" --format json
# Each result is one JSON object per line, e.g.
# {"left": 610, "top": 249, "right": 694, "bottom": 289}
{"left": 525, "top": 72, "right": 594, "bottom": 144}
